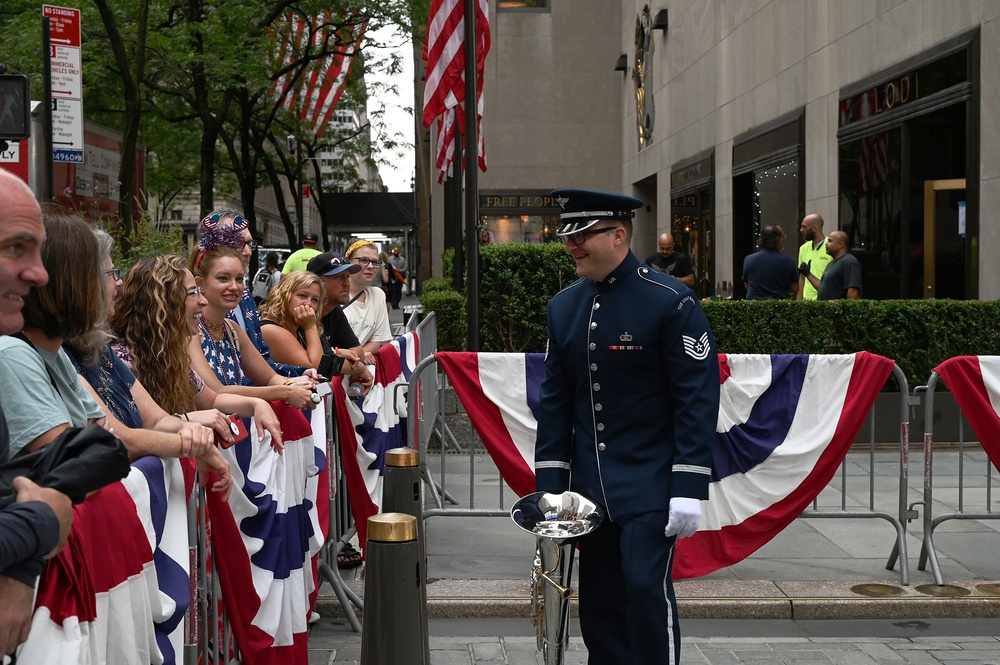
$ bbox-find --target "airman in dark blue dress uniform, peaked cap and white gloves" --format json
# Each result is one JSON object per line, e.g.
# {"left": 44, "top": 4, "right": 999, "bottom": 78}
{"left": 535, "top": 190, "right": 719, "bottom": 665}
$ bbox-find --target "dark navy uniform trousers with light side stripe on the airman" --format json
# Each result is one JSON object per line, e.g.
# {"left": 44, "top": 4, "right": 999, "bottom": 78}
{"left": 580, "top": 511, "right": 681, "bottom": 665}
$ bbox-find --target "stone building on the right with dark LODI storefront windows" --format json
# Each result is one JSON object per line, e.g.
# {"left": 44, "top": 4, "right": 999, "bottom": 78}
{"left": 618, "top": 0, "right": 1000, "bottom": 299}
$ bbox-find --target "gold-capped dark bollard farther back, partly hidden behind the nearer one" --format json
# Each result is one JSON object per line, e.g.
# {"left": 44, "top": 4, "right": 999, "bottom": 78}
{"left": 382, "top": 448, "right": 431, "bottom": 665}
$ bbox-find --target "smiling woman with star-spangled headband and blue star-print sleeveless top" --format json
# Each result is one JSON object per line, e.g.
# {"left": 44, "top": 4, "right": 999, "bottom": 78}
{"left": 188, "top": 220, "right": 317, "bottom": 409}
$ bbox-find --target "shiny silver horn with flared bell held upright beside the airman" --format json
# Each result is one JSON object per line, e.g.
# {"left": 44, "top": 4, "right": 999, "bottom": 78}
{"left": 510, "top": 492, "right": 604, "bottom": 665}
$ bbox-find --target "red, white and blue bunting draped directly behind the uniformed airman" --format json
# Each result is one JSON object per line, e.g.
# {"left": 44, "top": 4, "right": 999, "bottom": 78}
{"left": 435, "top": 352, "right": 893, "bottom": 579}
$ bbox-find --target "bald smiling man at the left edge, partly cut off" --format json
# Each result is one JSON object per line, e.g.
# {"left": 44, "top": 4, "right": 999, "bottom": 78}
{"left": 0, "top": 170, "right": 73, "bottom": 660}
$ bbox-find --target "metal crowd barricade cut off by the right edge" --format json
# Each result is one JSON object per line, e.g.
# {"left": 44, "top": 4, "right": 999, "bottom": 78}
{"left": 914, "top": 372, "right": 1000, "bottom": 585}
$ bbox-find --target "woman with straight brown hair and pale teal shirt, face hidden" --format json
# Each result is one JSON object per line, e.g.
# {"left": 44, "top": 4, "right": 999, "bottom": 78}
{"left": 0, "top": 215, "right": 231, "bottom": 494}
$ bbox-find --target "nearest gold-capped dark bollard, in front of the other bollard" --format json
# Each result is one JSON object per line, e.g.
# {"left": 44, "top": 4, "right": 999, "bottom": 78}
{"left": 361, "top": 513, "right": 430, "bottom": 665}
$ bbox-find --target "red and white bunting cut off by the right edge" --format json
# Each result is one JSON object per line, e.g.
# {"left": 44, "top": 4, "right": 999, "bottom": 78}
{"left": 934, "top": 356, "right": 1000, "bottom": 470}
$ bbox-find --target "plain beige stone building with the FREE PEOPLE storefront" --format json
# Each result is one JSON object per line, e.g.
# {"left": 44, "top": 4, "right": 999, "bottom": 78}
{"left": 426, "top": 0, "right": 623, "bottom": 276}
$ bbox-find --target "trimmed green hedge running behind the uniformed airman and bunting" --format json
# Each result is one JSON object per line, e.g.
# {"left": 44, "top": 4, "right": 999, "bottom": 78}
{"left": 421, "top": 243, "right": 1000, "bottom": 384}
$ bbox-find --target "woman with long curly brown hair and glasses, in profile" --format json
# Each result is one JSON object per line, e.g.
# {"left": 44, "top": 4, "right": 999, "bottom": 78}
{"left": 111, "top": 256, "right": 281, "bottom": 446}
